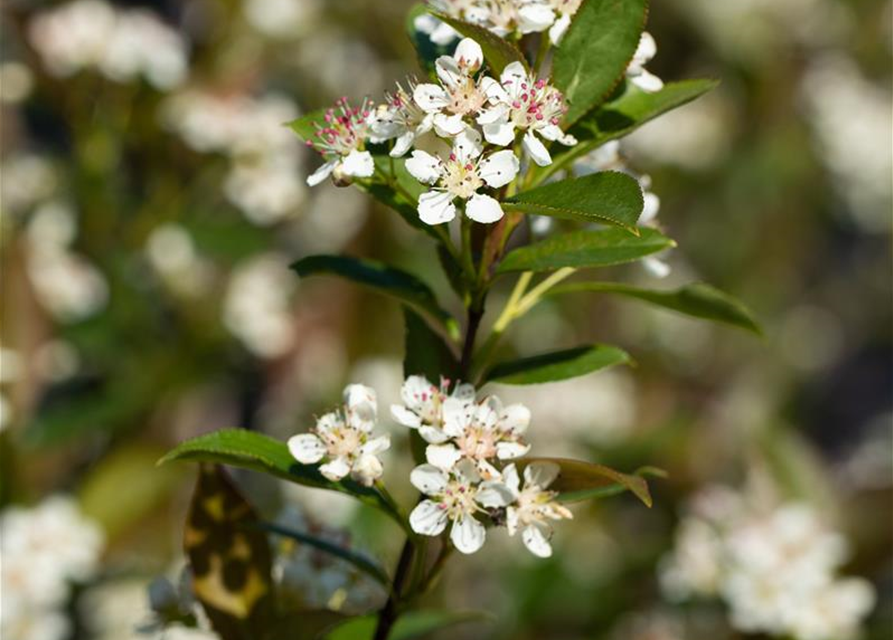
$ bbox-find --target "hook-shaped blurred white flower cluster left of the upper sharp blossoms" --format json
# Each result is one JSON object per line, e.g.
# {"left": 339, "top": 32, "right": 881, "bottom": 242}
{"left": 162, "top": 89, "right": 305, "bottom": 226}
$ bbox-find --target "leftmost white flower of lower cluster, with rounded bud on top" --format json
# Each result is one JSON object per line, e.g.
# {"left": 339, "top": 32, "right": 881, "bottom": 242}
{"left": 288, "top": 385, "right": 391, "bottom": 486}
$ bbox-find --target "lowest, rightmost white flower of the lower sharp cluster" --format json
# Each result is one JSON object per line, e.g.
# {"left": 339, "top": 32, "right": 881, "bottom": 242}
{"left": 502, "top": 462, "right": 574, "bottom": 558}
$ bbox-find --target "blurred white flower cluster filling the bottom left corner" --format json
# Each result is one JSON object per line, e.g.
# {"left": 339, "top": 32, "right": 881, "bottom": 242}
{"left": 0, "top": 496, "right": 104, "bottom": 640}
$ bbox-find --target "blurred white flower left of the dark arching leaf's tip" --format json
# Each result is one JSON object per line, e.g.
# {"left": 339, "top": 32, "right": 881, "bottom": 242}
{"left": 223, "top": 253, "right": 296, "bottom": 358}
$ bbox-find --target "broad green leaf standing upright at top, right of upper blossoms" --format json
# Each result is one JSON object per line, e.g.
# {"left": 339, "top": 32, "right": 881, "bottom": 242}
{"left": 552, "top": 0, "right": 648, "bottom": 124}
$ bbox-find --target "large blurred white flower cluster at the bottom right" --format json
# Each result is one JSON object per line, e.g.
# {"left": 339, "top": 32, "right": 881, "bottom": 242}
{"left": 661, "top": 488, "right": 875, "bottom": 640}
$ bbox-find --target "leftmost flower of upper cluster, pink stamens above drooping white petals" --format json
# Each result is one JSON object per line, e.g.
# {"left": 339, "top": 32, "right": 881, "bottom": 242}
{"left": 307, "top": 98, "right": 375, "bottom": 187}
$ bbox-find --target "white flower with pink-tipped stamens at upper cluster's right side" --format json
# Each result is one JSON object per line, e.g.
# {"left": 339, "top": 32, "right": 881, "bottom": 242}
{"left": 478, "top": 62, "right": 577, "bottom": 167}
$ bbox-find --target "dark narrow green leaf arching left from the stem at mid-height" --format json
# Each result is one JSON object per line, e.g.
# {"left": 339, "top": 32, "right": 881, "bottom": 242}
{"left": 291, "top": 255, "right": 459, "bottom": 335}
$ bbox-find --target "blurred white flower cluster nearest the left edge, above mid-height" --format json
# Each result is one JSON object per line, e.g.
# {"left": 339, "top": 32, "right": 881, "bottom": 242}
{"left": 27, "top": 201, "right": 109, "bottom": 322}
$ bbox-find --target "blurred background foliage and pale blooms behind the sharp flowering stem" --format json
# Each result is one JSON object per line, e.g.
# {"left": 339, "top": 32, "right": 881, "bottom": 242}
{"left": 0, "top": 0, "right": 893, "bottom": 640}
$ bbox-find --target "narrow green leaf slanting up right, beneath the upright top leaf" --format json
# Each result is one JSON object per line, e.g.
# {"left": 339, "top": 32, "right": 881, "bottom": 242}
{"left": 543, "top": 79, "right": 719, "bottom": 176}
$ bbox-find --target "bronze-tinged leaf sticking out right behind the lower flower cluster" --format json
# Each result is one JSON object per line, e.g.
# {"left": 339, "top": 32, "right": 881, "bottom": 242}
{"left": 516, "top": 458, "right": 666, "bottom": 507}
